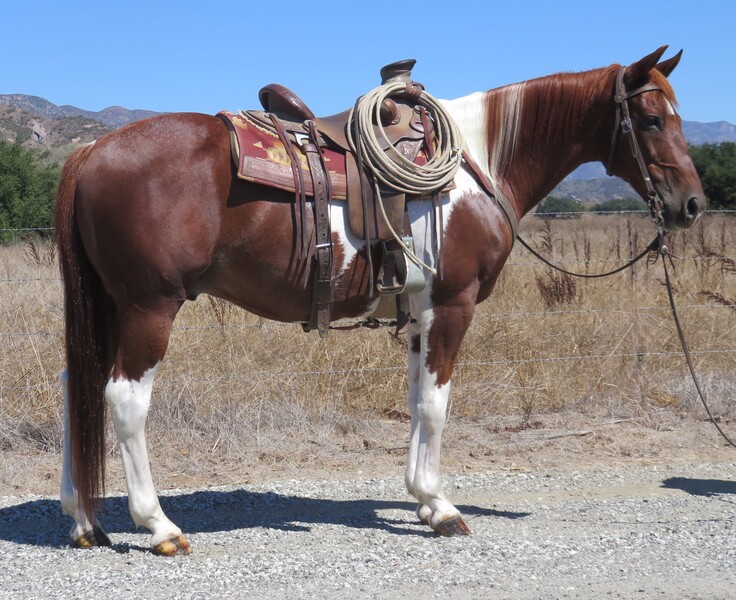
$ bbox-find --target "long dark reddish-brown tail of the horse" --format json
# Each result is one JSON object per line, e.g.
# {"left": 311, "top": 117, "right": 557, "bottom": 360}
{"left": 55, "top": 145, "right": 108, "bottom": 515}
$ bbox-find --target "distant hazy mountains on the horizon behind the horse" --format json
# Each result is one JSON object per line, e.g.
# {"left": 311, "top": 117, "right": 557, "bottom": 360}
{"left": 0, "top": 94, "right": 736, "bottom": 202}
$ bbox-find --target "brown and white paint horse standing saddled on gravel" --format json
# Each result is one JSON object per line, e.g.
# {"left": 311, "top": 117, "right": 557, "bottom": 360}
{"left": 55, "top": 46, "right": 705, "bottom": 555}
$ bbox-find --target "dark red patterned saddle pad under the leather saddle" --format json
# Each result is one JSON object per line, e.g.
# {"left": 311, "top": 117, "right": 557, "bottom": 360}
{"left": 217, "top": 111, "right": 347, "bottom": 200}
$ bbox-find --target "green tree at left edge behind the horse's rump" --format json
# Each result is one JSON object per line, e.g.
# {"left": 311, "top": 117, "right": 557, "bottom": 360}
{"left": 0, "top": 141, "right": 60, "bottom": 241}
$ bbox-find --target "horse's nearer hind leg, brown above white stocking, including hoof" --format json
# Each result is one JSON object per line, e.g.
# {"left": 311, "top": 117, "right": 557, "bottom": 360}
{"left": 105, "top": 301, "right": 191, "bottom": 556}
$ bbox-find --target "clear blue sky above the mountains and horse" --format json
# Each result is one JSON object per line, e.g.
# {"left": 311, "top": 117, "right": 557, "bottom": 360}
{"left": 5, "top": 0, "right": 736, "bottom": 123}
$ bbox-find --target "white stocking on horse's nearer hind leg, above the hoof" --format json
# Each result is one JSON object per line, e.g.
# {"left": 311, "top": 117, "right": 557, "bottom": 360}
{"left": 105, "top": 364, "right": 181, "bottom": 546}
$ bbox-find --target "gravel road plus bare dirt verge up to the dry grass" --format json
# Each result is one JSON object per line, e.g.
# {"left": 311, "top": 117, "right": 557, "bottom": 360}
{"left": 0, "top": 419, "right": 736, "bottom": 599}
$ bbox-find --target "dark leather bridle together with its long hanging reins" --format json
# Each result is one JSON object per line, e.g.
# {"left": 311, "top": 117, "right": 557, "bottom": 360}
{"left": 516, "top": 67, "right": 736, "bottom": 448}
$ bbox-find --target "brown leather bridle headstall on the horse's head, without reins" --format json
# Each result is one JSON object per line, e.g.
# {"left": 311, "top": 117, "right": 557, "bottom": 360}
{"left": 606, "top": 67, "right": 664, "bottom": 232}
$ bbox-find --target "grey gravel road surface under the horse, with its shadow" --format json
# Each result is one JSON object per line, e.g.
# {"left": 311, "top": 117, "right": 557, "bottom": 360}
{"left": 0, "top": 463, "right": 736, "bottom": 600}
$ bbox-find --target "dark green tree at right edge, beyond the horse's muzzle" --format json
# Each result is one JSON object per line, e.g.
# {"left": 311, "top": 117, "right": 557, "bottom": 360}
{"left": 690, "top": 142, "right": 736, "bottom": 209}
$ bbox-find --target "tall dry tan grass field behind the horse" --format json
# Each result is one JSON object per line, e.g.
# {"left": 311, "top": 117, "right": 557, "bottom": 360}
{"left": 0, "top": 215, "right": 736, "bottom": 480}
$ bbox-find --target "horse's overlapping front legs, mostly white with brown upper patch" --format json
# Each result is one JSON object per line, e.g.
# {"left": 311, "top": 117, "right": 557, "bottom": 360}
{"left": 405, "top": 305, "right": 473, "bottom": 536}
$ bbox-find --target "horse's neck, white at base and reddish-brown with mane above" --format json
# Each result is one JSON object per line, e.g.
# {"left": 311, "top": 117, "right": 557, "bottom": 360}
{"left": 447, "top": 69, "right": 613, "bottom": 215}
